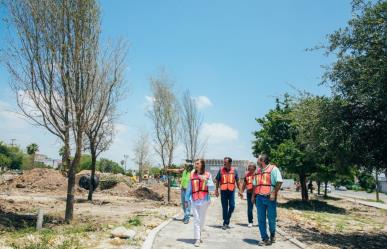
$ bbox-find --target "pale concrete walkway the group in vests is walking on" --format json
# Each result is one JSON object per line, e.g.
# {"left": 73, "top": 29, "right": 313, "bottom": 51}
{"left": 152, "top": 197, "right": 299, "bottom": 249}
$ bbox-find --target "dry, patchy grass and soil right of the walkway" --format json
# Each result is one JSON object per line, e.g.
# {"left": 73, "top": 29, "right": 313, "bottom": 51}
{"left": 278, "top": 192, "right": 387, "bottom": 249}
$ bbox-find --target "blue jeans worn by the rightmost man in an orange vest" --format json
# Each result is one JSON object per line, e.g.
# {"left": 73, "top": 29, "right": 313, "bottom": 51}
{"left": 255, "top": 195, "right": 277, "bottom": 240}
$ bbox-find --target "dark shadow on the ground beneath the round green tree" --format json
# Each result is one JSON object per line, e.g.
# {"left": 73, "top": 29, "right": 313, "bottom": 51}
{"left": 278, "top": 200, "right": 346, "bottom": 214}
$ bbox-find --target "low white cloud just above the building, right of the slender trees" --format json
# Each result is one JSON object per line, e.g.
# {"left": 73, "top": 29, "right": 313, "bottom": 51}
{"left": 202, "top": 123, "right": 239, "bottom": 143}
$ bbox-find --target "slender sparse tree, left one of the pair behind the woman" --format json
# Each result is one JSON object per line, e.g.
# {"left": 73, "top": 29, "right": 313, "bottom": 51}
{"left": 148, "top": 72, "right": 179, "bottom": 202}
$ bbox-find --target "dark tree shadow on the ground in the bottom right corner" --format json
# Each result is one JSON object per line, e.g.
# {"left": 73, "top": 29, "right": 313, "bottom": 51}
{"left": 287, "top": 225, "right": 387, "bottom": 249}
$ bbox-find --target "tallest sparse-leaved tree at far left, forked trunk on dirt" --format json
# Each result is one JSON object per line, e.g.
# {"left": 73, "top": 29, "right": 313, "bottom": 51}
{"left": 6, "top": 0, "right": 106, "bottom": 223}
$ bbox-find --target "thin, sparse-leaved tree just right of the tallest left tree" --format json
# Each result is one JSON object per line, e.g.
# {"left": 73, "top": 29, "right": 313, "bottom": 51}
{"left": 85, "top": 40, "right": 127, "bottom": 201}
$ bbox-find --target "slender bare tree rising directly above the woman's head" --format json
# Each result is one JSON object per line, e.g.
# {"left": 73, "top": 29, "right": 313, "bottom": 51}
{"left": 181, "top": 91, "right": 206, "bottom": 162}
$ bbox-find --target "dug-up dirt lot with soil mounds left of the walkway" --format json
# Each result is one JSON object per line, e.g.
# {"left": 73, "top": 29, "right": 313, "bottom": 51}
{"left": 0, "top": 168, "right": 180, "bottom": 248}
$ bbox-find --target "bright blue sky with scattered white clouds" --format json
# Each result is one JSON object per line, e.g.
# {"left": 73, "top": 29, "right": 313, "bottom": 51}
{"left": 0, "top": 0, "right": 351, "bottom": 168}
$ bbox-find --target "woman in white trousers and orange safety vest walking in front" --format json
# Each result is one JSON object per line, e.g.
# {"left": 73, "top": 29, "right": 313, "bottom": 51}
{"left": 185, "top": 159, "right": 214, "bottom": 247}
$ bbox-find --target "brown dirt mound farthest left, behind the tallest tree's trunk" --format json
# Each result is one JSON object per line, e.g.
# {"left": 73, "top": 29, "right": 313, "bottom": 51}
{"left": 5, "top": 168, "right": 67, "bottom": 191}
